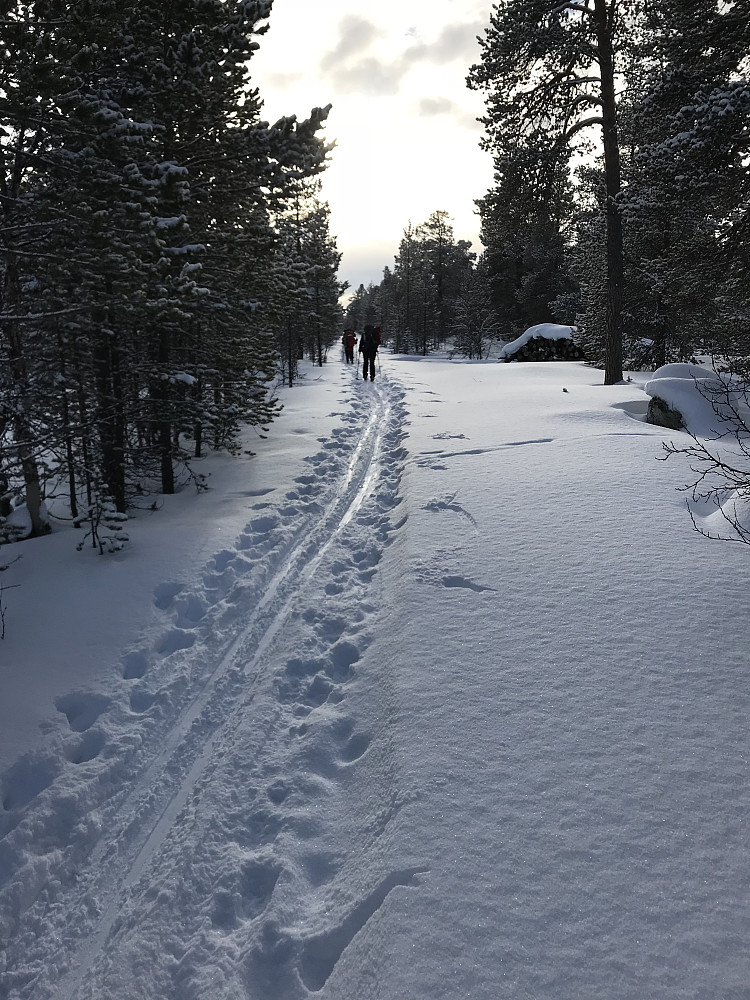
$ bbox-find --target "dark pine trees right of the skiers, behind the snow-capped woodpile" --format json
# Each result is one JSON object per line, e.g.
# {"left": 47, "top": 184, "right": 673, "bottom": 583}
{"left": 362, "top": 0, "right": 750, "bottom": 383}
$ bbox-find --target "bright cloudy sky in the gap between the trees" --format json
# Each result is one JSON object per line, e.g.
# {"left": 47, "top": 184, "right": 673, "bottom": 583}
{"left": 251, "top": 0, "right": 492, "bottom": 288}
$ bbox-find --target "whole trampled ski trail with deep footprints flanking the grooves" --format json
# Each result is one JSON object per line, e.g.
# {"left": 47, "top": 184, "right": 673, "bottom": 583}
{"left": 0, "top": 372, "right": 418, "bottom": 1000}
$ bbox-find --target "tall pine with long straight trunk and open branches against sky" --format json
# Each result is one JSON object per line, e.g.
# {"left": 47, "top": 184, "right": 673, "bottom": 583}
{"left": 468, "top": 0, "right": 641, "bottom": 384}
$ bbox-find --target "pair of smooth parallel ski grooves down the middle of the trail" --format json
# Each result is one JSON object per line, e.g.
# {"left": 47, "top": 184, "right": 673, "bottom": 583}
{"left": 54, "top": 386, "right": 391, "bottom": 1000}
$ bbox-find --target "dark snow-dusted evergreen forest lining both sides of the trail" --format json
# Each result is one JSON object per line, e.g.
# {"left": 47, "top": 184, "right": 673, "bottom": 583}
{"left": 0, "top": 0, "right": 750, "bottom": 547}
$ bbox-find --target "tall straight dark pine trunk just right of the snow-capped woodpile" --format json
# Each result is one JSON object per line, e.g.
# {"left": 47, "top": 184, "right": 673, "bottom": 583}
{"left": 594, "top": 0, "right": 624, "bottom": 385}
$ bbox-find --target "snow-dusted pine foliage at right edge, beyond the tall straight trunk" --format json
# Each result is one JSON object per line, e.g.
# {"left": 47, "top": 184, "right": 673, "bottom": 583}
{"left": 622, "top": 0, "right": 750, "bottom": 366}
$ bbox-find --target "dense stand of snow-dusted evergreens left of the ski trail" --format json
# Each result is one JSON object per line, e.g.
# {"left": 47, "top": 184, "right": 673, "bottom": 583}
{"left": 0, "top": 0, "right": 341, "bottom": 536}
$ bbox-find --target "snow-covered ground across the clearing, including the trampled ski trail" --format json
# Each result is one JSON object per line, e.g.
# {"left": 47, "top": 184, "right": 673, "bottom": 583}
{"left": 0, "top": 355, "right": 750, "bottom": 1000}
